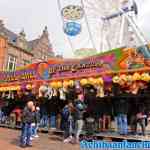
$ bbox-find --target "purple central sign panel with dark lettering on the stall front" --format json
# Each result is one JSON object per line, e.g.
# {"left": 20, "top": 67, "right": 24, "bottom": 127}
{"left": 49, "top": 53, "right": 116, "bottom": 79}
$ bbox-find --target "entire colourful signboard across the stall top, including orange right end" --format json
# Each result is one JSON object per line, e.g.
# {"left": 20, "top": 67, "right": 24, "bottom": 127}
{"left": 0, "top": 45, "right": 150, "bottom": 83}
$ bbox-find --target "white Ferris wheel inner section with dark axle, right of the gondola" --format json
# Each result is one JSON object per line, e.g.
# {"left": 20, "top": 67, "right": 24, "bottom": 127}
{"left": 81, "top": 0, "right": 144, "bottom": 52}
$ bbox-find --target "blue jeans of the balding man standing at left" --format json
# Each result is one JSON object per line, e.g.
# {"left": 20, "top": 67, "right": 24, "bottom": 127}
{"left": 20, "top": 123, "right": 32, "bottom": 145}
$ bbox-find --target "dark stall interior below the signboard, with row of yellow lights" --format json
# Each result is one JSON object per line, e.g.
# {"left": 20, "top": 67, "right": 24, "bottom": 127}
{"left": 0, "top": 72, "right": 150, "bottom": 135}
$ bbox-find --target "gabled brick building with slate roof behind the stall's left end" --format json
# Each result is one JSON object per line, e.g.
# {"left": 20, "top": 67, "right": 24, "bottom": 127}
{"left": 0, "top": 20, "right": 54, "bottom": 71}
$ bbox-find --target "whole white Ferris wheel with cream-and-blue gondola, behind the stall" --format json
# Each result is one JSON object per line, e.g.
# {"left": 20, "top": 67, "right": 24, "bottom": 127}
{"left": 58, "top": 0, "right": 146, "bottom": 55}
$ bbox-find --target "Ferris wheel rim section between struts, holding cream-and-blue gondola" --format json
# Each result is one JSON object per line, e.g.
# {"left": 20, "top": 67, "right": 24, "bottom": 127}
{"left": 57, "top": 0, "right": 96, "bottom": 57}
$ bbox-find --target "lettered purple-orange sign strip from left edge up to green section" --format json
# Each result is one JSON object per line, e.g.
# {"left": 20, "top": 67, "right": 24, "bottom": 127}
{"left": 0, "top": 49, "right": 117, "bottom": 83}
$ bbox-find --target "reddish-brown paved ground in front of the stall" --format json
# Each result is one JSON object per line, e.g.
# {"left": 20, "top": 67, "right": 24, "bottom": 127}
{"left": 0, "top": 128, "right": 80, "bottom": 150}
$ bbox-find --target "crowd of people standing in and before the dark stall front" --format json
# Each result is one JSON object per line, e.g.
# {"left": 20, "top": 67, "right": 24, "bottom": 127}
{"left": 1, "top": 85, "right": 150, "bottom": 147}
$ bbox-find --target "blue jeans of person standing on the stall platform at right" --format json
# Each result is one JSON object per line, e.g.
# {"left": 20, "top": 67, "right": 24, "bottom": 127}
{"left": 117, "top": 114, "right": 128, "bottom": 135}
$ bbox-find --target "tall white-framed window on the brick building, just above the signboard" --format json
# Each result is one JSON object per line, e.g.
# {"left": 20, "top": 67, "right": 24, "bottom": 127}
{"left": 7, "top": 55, "right": 17, "bottom": 71}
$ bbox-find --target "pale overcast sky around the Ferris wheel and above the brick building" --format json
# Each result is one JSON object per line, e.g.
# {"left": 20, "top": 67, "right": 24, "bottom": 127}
{"left": 0, "top": 0, "right": 150, "bottom": 57}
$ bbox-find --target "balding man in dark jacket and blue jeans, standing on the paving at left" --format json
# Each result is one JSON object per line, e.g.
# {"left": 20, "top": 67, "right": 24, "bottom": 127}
{"left": 20, "top": 101, "right": 35, "bottom": 147}
